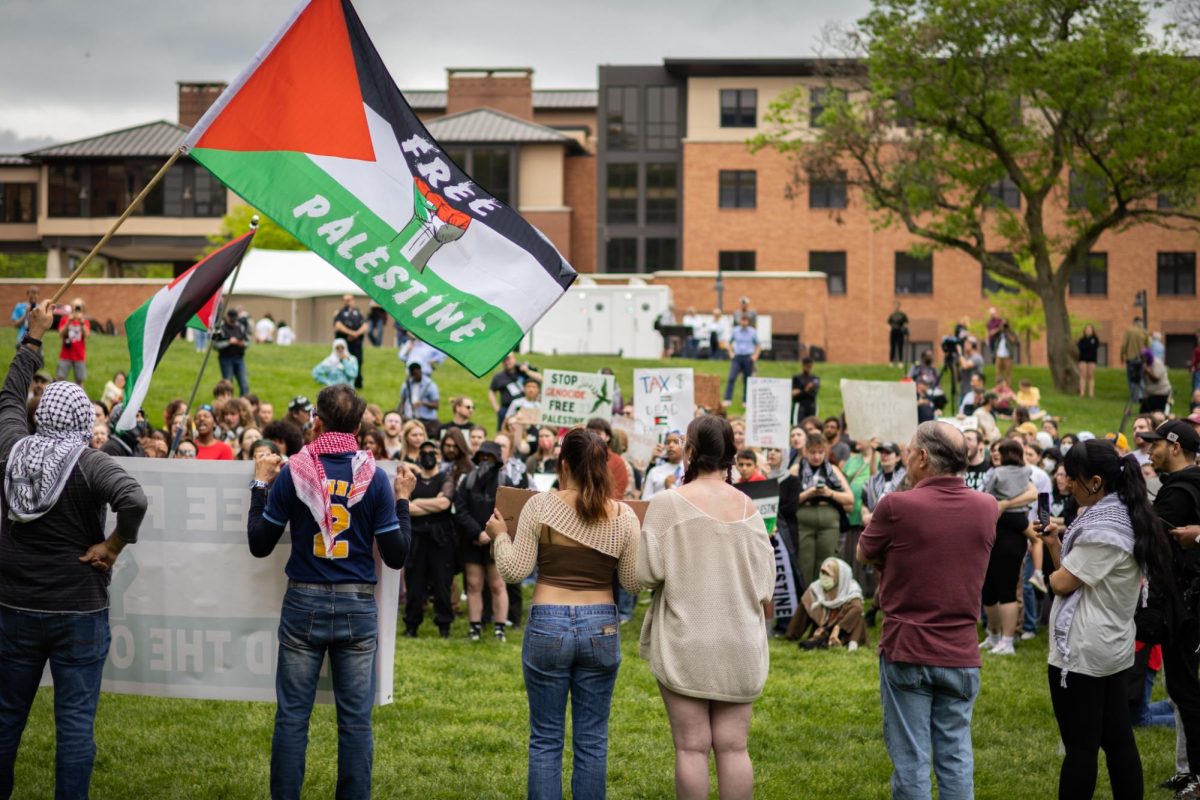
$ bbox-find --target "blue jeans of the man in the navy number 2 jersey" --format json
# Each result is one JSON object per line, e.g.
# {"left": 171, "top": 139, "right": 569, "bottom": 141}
{"left": 271, "top": 584, "right": 376, "bottom": 800}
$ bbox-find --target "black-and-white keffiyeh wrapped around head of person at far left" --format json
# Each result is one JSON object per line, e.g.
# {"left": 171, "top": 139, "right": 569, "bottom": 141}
{"left": 4, "top": 380, "right": 96, "bottom": 522}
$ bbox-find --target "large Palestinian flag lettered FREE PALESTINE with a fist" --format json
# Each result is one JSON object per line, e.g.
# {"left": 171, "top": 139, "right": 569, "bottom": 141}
{"left": 185, "top": 0, "right": 575, "bottom": 375}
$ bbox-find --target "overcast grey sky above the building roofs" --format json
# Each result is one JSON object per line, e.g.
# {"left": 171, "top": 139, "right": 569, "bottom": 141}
{"left": 0, "top": 0, "right": 869, "bottom": 152}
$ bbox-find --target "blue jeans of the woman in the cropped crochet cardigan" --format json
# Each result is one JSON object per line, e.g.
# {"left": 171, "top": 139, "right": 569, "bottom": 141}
{"left": 521, "top": 604, "right": 620, "bottom": 800}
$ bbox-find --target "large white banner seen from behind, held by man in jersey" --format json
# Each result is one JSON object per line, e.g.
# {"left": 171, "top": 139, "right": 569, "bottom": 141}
{"left": 46, "top": 458, "right": 400, "bottom": 705}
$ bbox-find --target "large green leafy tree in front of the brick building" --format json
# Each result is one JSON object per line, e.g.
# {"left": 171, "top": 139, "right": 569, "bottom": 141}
{"left": 751, "top": 0, "right": 1200, "bottom": 391}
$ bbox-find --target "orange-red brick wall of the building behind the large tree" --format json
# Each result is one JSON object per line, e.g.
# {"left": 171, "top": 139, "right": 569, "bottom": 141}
{"left": 676, "top": 143, "right": 1200, "bottom": 363}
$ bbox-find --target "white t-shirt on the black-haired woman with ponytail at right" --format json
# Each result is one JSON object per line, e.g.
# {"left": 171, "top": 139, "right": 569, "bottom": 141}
{"left": 1049, "top": 543, "right": 1141, "bottom": 680}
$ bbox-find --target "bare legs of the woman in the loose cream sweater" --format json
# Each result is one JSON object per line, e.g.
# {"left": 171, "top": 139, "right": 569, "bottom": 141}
{"left": 659, "top": 684, "right": 754, "bottom": 800}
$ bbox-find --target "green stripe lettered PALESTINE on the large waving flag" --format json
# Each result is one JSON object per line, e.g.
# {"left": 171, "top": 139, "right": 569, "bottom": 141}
{"left": 191, "top": 148, "right": 523, "bottom": 377}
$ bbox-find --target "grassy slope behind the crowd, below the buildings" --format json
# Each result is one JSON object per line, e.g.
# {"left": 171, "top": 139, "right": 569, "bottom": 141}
{"left": 16, "top": 329, "right": 1190, "bottom": 435}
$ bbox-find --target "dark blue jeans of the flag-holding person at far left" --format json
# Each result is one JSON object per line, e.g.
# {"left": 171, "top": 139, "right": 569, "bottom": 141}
{"left": 0, "top": 607, "right": 112, "bottom": 800}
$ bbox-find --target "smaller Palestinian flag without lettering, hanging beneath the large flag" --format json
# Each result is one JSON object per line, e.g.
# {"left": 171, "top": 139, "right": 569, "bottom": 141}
{"left": 116, "top": 230, "right": 254, "bottom": 431}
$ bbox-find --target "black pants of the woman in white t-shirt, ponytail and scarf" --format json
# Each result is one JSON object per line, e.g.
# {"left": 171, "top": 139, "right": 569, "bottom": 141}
{"left": 1049, "top": 667, "right": 1142, "bottom": 800}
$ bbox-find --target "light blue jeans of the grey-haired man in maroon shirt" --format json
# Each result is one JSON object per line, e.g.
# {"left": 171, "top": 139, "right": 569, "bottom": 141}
{"left": 880, "top": 655, "right": 979, "bottom": 800}
